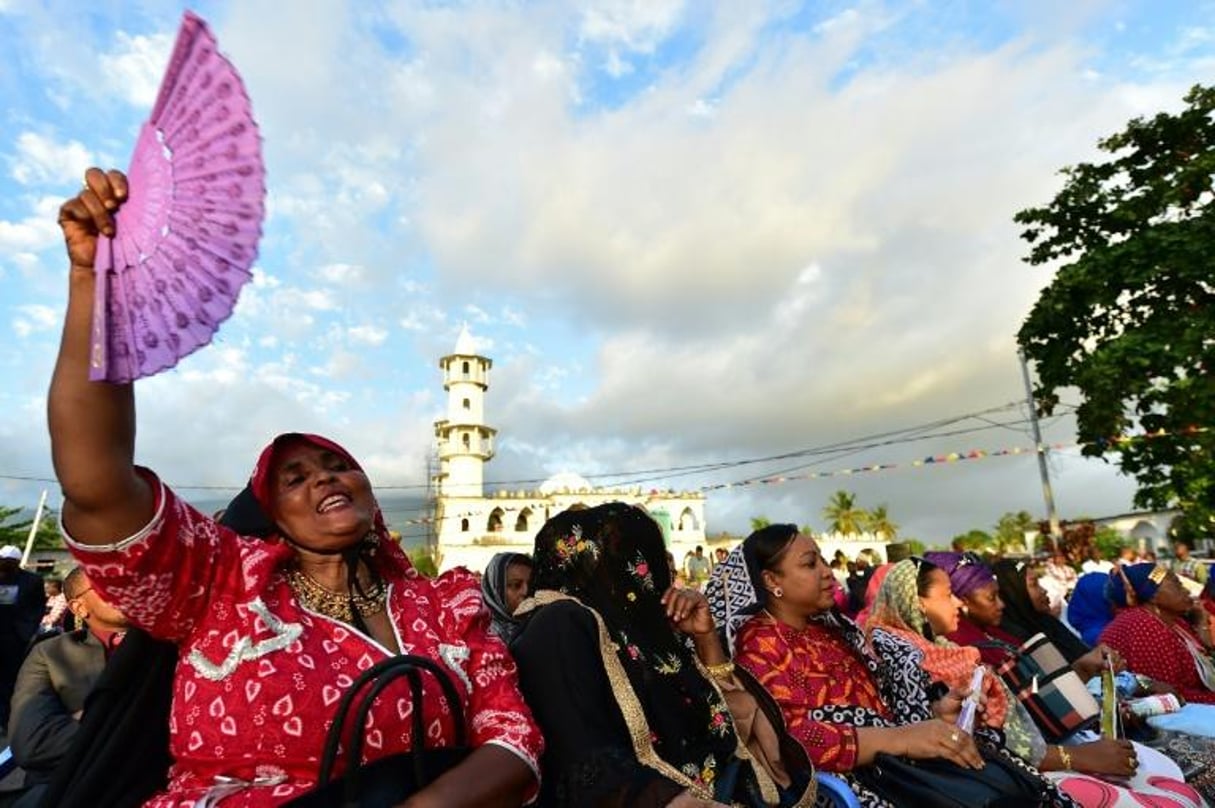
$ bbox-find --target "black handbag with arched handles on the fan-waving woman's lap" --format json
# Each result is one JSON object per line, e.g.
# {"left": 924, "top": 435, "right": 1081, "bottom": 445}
{"left": 287, "top": 655, "right": 471, "bottom": 808}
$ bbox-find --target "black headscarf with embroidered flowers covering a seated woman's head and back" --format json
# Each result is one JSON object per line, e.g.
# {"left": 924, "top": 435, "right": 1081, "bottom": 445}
{"left": 532, "top": 502, "right": 738, "bottom": 781}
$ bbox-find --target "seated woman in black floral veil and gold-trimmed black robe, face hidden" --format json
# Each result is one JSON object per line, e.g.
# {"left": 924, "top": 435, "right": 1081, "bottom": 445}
{"left": 510, "top": 503, "right": 810, "bottom": 808}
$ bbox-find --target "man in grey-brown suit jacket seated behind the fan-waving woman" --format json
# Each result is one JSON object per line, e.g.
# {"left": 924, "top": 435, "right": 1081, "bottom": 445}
{"left": 10, "top": 567, "right": 128, "bottom": 806}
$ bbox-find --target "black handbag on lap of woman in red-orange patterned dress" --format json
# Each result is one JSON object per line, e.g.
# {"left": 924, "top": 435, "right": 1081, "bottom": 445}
{"left": 853, "top": 752, "right": 1050, "bottom": 808}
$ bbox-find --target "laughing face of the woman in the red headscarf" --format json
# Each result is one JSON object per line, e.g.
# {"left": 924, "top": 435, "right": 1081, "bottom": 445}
{"left": 270, "top": 441, "right": 375, "bottom": 550}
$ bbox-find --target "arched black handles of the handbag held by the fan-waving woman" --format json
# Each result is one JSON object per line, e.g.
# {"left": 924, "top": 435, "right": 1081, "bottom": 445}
{"left": 317, "top": 654, "right": 468, "bottom": 804}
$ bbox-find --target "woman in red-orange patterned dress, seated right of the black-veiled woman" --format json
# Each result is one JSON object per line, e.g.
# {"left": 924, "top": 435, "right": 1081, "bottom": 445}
{"left": 729, "top": 525, "right": 1073, "bottom": 807}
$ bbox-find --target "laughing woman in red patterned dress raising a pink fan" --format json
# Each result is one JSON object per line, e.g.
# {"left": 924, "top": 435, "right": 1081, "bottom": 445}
{"left": 49, "top": 169, "right": 542, "bottom": 808}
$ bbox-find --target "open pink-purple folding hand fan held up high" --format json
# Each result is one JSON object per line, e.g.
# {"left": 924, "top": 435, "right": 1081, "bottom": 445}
{"left": 89, "top": 11, "right": 266, "bottom": 383}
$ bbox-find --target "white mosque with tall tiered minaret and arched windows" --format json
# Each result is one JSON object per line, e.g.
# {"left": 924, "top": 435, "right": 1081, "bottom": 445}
{"left": 434, "top": 327, "right": 707, "bottom": 570}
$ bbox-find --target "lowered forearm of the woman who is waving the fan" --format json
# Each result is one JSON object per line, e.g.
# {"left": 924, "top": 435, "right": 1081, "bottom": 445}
{"left": 399, "top": 745, "right": 536, "bottom": 808}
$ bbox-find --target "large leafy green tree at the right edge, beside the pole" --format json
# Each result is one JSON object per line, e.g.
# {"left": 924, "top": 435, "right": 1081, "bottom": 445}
{"left": 1016, "top": 85, "right": 1215, "bottom": 525}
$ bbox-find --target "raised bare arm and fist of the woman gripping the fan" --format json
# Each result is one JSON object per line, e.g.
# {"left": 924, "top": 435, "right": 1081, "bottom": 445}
{"left": 46, "top": 168, "right": 153, "bottom": 544}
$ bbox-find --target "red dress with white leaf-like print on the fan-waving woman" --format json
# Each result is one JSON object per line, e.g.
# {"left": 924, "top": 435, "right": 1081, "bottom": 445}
{"left": 64, "top": 470, "right": 543, "bottom": 808}
